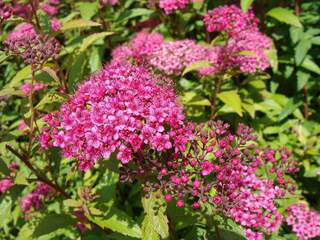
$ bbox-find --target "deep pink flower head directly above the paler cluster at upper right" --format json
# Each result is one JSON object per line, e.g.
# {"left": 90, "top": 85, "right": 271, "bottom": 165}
{"left": 204, "top": 5, "right": 258, "bottom": 36}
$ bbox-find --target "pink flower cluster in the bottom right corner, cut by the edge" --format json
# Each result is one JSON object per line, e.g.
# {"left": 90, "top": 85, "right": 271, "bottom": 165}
{"left": 286, "top": 203, "right": 320, "bottom": 240}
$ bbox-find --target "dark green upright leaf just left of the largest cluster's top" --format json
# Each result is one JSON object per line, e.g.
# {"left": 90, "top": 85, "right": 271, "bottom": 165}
{"left": 68, "top": 52, "right": 87, "bottom": 92}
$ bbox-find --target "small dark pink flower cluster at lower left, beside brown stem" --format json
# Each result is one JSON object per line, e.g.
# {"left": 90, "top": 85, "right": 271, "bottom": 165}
{"left": 20, "top": 182, "right": 54, "bottom": 213}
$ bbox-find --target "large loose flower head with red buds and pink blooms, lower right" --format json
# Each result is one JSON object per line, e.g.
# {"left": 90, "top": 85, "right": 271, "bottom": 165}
{"left": 143, "top": 121, "right": 298, "bottom": 239}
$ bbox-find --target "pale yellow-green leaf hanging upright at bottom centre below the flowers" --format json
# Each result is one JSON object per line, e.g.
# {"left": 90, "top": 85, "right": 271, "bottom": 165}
{"left": 142, "top": 193, "right": 169, "bottom": 239}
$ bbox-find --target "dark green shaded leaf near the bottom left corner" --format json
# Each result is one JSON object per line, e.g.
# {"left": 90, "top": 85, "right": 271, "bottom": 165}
{"left": 32, "top": 213, "right": 77, "bottom": 237}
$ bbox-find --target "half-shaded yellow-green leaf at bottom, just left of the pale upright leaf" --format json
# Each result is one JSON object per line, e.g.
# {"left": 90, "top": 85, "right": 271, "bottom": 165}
{"left": 87, "top": 207, "right": 141, "bottom": 238}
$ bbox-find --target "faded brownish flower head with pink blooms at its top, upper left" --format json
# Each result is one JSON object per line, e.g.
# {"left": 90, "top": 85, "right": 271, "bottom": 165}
{"left": 4, "top": 23, "right": 60, "bottom": 69}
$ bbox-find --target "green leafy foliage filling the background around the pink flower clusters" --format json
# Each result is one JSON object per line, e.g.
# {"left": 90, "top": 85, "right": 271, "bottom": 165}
{"left": 0, "top": 0, "right": 320, "bottom": 240}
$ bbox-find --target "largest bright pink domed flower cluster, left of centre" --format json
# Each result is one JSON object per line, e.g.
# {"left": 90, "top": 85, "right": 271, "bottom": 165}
{"left": 40, "top": 63, "right": 191, "bottom": 171}
